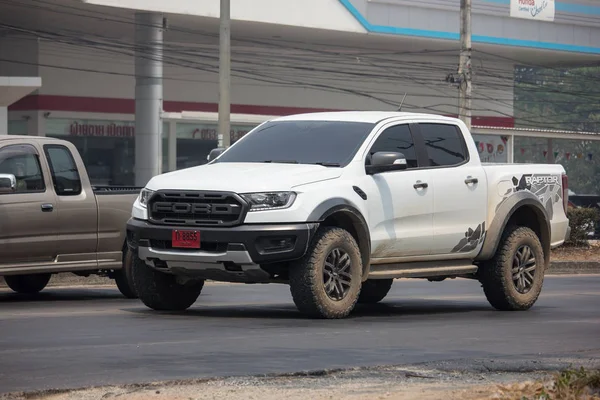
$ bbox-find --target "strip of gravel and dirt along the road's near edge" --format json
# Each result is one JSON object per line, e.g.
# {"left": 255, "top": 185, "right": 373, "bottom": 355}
{"left": 5, "top": 357, "right": 600, "bottom": 400}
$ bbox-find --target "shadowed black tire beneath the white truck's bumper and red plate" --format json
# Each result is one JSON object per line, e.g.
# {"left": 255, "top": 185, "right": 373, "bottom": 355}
{"left": 132, "top": 255, "right": 204, "bottom": 311}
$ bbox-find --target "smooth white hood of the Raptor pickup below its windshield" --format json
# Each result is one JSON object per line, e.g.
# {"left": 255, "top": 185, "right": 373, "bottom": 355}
{"left": 146, "top": 163, "right": 342, "bottom": 193}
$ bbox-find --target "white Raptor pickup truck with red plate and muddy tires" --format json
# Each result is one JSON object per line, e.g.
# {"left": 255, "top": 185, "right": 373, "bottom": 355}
{"left": 127, "top": 112, "right": 569, "bottom": 318}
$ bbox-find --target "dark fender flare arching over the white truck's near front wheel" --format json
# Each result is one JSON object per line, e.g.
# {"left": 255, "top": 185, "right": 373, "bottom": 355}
{"left": 308, "top": 197, "right": 371, "bottom": 281}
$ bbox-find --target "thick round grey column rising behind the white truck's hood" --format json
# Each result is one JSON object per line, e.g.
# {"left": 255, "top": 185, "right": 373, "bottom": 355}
{"left": 135, "top": 13, "right": 163, "bottom": 186}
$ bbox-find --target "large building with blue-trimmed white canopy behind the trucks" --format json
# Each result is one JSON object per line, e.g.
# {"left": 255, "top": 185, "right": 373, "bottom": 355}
{"left": 0, "top": 0, "right": 600, "bottom": 192}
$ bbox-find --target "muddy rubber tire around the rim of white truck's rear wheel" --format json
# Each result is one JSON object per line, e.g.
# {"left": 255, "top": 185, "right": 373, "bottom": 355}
{"left": 479, "top": 226, "right": 545, "bottom": 311}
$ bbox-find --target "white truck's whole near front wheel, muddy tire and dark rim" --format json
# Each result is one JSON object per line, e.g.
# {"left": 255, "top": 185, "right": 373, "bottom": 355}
{"left": 290, "top": 227, "right": 362, "bottom": 319}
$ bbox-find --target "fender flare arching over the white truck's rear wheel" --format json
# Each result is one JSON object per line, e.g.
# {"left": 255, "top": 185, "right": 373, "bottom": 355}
{"left": 475, "top": 191, "right": 551, "bottom": 265}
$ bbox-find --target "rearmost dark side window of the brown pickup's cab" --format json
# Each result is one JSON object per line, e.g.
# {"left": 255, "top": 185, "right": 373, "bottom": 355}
{"left": 44, "top": 145, "right": 81, "bottom": 196}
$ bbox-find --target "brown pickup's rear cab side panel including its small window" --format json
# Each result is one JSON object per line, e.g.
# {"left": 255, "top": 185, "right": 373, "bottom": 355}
{"left": 44, "top": 143, "right": 98, "bottom": 262}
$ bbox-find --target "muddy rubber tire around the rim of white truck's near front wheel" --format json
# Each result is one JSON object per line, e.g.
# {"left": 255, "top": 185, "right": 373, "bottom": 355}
{"left": 290, "top": 227, "right": 362, "bottom": 319}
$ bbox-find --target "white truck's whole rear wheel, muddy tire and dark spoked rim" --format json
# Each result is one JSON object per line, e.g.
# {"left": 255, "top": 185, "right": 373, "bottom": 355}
{"left": 479, "top": 227, "right": 545, "bottom": 311}
